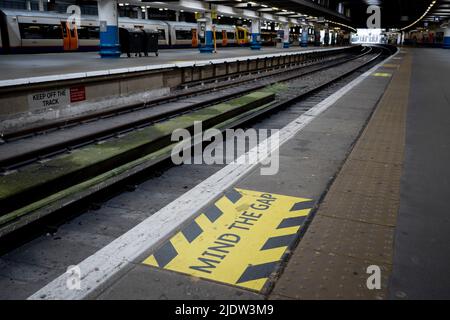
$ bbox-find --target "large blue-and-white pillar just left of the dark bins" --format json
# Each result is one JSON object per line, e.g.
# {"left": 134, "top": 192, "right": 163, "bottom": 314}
{"left": 98, "top": 0, "right": 120, "bottom": 58}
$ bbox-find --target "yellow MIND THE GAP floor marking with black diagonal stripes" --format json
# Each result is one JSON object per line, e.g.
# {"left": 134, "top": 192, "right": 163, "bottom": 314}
{"left": 143, "top": 189, "right": 314, "bottom": 291}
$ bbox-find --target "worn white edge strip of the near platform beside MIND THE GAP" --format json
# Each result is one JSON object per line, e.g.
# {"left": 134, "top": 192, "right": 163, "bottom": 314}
{"left": 28, "top": 51, "right": 399, "bottom": 300}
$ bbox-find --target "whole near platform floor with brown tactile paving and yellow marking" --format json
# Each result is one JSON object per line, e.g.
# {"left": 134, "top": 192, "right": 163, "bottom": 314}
{"left": 24, "top": 48, "right": 450, "bottom": 299}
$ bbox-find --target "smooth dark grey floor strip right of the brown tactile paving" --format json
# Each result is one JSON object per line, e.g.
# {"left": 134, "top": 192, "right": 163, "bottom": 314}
{"left": 390, "top": 49, "right": 450, "bottom": 299}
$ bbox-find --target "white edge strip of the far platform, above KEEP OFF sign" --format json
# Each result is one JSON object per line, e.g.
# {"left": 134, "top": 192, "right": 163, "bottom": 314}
{"left": 0, "top": 47, "right": 347, "bottom": 88}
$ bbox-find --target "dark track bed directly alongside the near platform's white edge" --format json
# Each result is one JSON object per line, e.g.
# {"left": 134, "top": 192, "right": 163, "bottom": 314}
{"left": 0, "top": 45, "right": 394, "bottom": 298}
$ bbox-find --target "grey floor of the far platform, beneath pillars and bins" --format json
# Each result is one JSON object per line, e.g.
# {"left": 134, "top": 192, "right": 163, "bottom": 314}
{"left": 0, "top": 46, "right": 337, "bottom": 80}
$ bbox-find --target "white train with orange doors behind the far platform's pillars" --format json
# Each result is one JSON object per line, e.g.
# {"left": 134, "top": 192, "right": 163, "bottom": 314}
{"left": 0, "top": 9, "right": 250, "bottom": 53}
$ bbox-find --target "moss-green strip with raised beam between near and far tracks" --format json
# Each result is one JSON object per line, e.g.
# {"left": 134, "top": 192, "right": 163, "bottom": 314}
{"left": 0, "top": 46, "right": 381, "bottom": 240}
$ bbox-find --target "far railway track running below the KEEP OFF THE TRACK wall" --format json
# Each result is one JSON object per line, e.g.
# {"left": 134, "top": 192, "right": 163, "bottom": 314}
{"left": 0, "top": 47, "right": 364, "bottom": 174}
